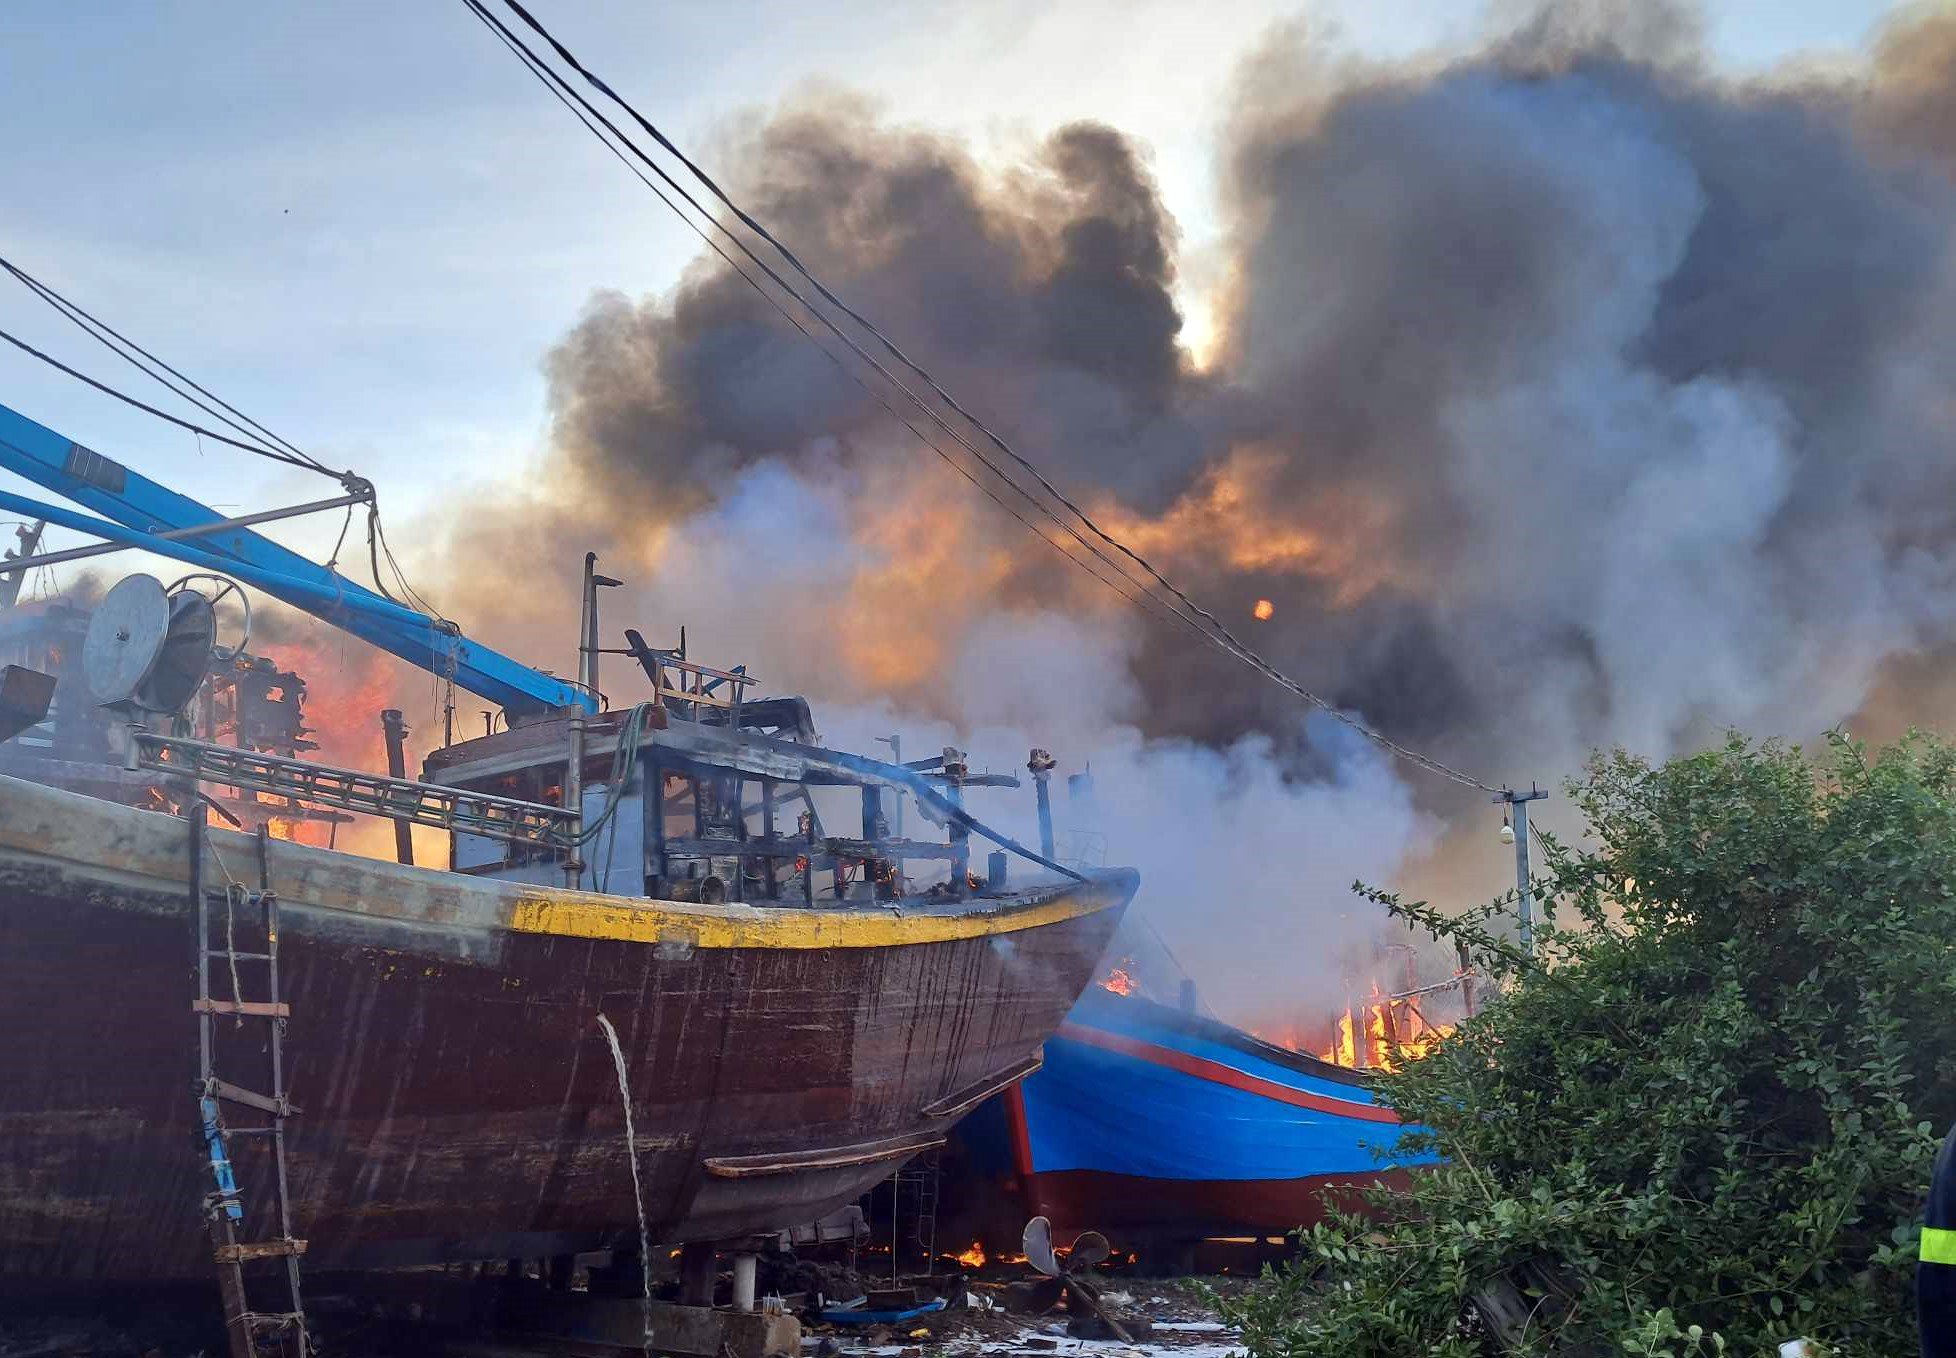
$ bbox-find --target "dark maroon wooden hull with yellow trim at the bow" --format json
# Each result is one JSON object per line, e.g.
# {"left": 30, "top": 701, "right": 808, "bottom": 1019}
{"left": 0, "top": 779, "right": 1134, "bottom": 1280}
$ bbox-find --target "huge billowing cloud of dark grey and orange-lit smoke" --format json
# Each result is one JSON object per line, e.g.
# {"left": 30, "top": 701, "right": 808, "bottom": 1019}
{"left": 289, "top": 4, "right": 1956, "bottom": 1023}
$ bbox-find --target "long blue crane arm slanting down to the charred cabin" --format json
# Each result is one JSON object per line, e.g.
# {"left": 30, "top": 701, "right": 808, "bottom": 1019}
{"left": 0, "top": 405, "right": 597, "bottom": 716}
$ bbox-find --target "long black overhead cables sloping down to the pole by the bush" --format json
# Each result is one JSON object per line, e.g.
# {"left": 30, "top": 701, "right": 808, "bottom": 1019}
{"left": 464, "top": 0, "right": 1500, "bottom": 792}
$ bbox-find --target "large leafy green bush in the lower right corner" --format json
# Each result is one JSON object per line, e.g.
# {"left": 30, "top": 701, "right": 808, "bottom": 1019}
{"left": 1228, "top": 736, "right": 1956, "bottom": 1358}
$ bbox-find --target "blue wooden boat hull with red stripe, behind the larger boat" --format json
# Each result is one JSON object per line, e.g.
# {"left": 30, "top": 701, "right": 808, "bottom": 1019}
{"left": 958, "top": 986, "right": 1432, "bottom": 1245}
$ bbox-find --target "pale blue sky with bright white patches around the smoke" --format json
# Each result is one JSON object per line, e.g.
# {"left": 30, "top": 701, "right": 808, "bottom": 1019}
{"left": 0, "top": 0, "right": 1888, "bottom": 579}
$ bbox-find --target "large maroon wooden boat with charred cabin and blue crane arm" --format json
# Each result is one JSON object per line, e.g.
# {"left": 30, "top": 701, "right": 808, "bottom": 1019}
{"left": 0, "top": 407, "right": 1136, "bottom": 1283}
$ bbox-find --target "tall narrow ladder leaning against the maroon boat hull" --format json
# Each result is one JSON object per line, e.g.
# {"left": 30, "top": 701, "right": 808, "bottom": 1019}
{"left": 186, "top": 810, "right": 311, "bottom": 1358}
